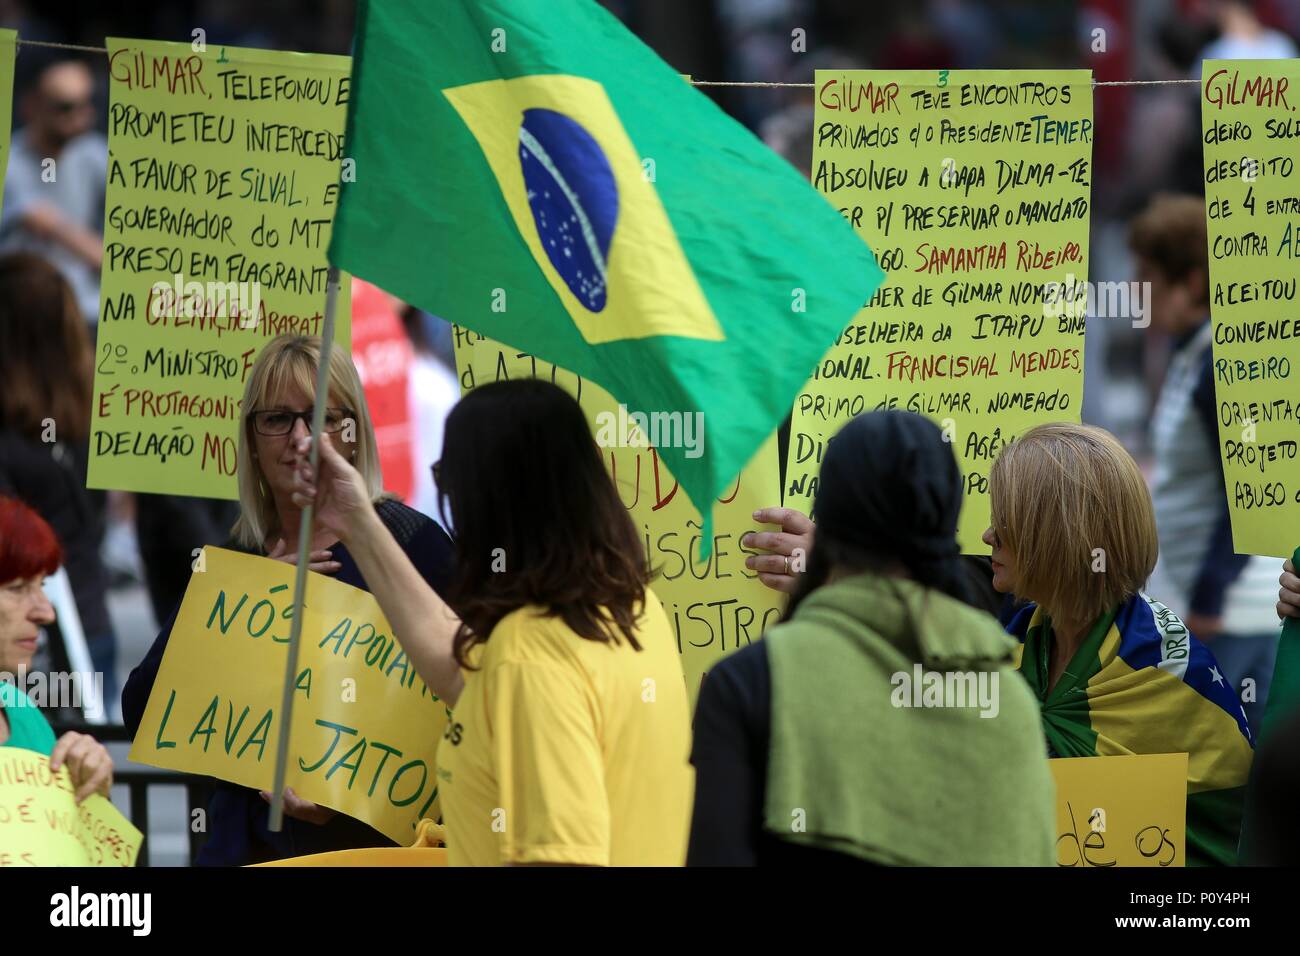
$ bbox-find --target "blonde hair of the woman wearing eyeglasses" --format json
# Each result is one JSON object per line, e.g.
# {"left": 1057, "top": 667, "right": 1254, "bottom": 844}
{"left": 231, "top": 334, "right": 387, "bottom": 551}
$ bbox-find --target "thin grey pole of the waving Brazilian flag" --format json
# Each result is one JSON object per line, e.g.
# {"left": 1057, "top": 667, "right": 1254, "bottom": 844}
{"left": 270, "top": 265, "right": 339, "bottom": 832}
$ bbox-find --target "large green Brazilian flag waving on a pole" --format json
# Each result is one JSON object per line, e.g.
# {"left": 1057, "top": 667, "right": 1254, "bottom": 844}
{"left": 329, "top": 0, "right": 883, "bottom": 530}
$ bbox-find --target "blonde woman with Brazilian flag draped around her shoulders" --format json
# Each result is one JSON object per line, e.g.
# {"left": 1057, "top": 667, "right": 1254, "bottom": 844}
{"left": 746, "top": 423, "right": 1252, "bottom": 865}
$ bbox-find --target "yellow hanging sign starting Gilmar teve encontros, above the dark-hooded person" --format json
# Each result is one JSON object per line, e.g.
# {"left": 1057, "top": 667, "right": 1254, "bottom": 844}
{"left": 784, "top": 70, "right": 1092, "bottom": 553}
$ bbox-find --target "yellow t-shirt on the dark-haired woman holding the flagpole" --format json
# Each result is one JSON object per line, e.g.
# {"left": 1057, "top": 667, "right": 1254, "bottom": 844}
{"left": 438, "top": 591, "right": 694, "bottom": 866}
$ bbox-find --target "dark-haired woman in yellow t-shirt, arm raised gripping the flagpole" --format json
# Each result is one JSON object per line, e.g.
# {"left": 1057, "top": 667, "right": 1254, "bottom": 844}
{"left": 295, "top": 380, "right": 692, "bottom": 866}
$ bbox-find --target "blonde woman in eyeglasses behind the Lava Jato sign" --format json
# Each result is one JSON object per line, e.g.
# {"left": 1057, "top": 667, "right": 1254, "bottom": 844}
{"left": 122, "top": 334, "right": 454, "bottom": 866}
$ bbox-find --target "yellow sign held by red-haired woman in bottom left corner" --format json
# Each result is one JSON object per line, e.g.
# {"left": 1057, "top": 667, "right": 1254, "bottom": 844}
{"left": 0, "top": 747, "right": 144, "bottom": 866}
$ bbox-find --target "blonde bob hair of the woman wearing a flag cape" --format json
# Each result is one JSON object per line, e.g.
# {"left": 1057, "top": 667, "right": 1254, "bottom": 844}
{"left": 988, "top": 423, "right": 1158, "bottom": 627}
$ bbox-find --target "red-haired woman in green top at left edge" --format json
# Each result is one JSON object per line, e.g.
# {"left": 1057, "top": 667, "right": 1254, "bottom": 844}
{"left": 0, "top": 498, "right": 113, "bottom": 803}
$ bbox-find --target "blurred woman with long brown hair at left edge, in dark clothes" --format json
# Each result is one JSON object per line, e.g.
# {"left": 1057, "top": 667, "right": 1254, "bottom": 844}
{"left": 0, "top": 252, "right": 117, "bottom": 701}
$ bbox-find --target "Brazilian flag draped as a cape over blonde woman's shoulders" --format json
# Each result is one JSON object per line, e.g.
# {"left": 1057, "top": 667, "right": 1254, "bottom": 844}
{"left": 1006, "top": 593, "right": 1253, "bottom": 865}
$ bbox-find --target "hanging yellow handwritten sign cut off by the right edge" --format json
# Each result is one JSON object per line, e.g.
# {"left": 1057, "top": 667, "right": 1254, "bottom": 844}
{"left": 1201, "top": 60, "right": 1300, "bottom": 557}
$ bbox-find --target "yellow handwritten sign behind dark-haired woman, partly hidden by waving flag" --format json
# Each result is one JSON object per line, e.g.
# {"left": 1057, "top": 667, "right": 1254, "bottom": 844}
{"left": 454, "top": 325, "right": 784, "bottom": 706}
